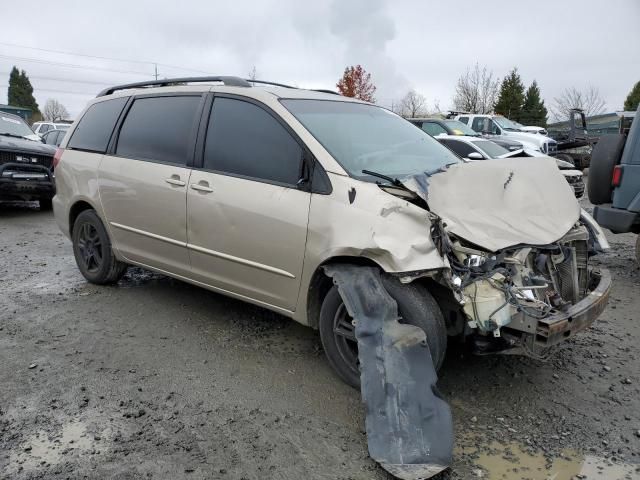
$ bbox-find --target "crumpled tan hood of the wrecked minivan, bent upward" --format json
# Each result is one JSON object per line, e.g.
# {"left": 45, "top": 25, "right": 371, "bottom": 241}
{"left": 403, "top": 158, "right": 580, "bottom": 252}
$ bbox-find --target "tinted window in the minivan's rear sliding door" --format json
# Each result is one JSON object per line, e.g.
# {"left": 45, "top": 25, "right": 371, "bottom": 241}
{"left": 116, "top": 96, "right": 201, "bottom": 165}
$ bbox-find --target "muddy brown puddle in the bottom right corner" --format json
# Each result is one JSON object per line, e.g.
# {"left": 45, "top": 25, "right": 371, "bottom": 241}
{"left": 464, "top": 442, "right": 640, "bottom": 480}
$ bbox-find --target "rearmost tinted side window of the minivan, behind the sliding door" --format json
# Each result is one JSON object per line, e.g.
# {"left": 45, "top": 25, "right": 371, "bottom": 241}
{"left": 67, "top": 97, "right": 127, "bottom": 153}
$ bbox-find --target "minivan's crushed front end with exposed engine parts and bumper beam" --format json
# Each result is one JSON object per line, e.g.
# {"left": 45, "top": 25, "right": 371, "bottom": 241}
{"left": 432, "top": 221, "right": 611, "bottom": 357}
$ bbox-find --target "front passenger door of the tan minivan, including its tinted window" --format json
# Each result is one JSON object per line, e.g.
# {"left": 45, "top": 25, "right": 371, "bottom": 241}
{"left": 187, "top": 97, "right": 311, "bottom": 310}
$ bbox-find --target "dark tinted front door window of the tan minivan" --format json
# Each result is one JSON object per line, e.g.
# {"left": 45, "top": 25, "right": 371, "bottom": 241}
{"left": 204, "top": 98, "right": 302, "bottom": 185}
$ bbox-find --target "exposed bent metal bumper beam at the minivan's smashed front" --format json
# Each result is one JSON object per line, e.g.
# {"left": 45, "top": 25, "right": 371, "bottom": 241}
{"left": 504, "top": 268, "right": 611, "bottom": 355}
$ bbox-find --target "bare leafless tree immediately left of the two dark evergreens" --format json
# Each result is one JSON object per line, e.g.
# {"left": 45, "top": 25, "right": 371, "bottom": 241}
{"left": 453, "top": 63, "right": 500, "bottom": 113}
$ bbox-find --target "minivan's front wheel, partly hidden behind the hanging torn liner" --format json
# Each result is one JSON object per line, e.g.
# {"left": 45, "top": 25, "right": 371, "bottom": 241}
{"left": 319, "top": 276, "right": 447, "bottom": 389}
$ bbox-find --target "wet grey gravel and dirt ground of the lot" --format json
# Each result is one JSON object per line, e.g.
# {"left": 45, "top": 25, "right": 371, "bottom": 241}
{"left": 0, "top": 197, "right": 640, "bottom": 480}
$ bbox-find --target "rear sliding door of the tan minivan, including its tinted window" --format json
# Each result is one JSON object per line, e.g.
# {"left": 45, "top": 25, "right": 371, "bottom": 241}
{"left": 98, "top": 95, "right": 202, "bottom": 276}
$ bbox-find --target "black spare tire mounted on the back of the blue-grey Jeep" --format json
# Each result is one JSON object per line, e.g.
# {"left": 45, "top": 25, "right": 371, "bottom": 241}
{"left": 587, "top": 133, "right": 626, "bottom": 205}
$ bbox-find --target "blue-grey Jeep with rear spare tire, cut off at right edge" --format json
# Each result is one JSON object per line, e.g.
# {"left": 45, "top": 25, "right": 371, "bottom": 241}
{"left": 589, "top": 107, "right": 640, "bottom": 263}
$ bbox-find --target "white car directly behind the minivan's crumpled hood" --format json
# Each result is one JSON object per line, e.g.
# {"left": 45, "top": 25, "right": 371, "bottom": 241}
{"left": 437, "top": 135, "right": 585, "bottom": 198}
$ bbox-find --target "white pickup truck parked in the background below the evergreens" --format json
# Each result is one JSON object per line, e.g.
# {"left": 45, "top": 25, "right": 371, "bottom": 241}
{"left": 454, "top": 113, "right": 558, "bottom": 156}
